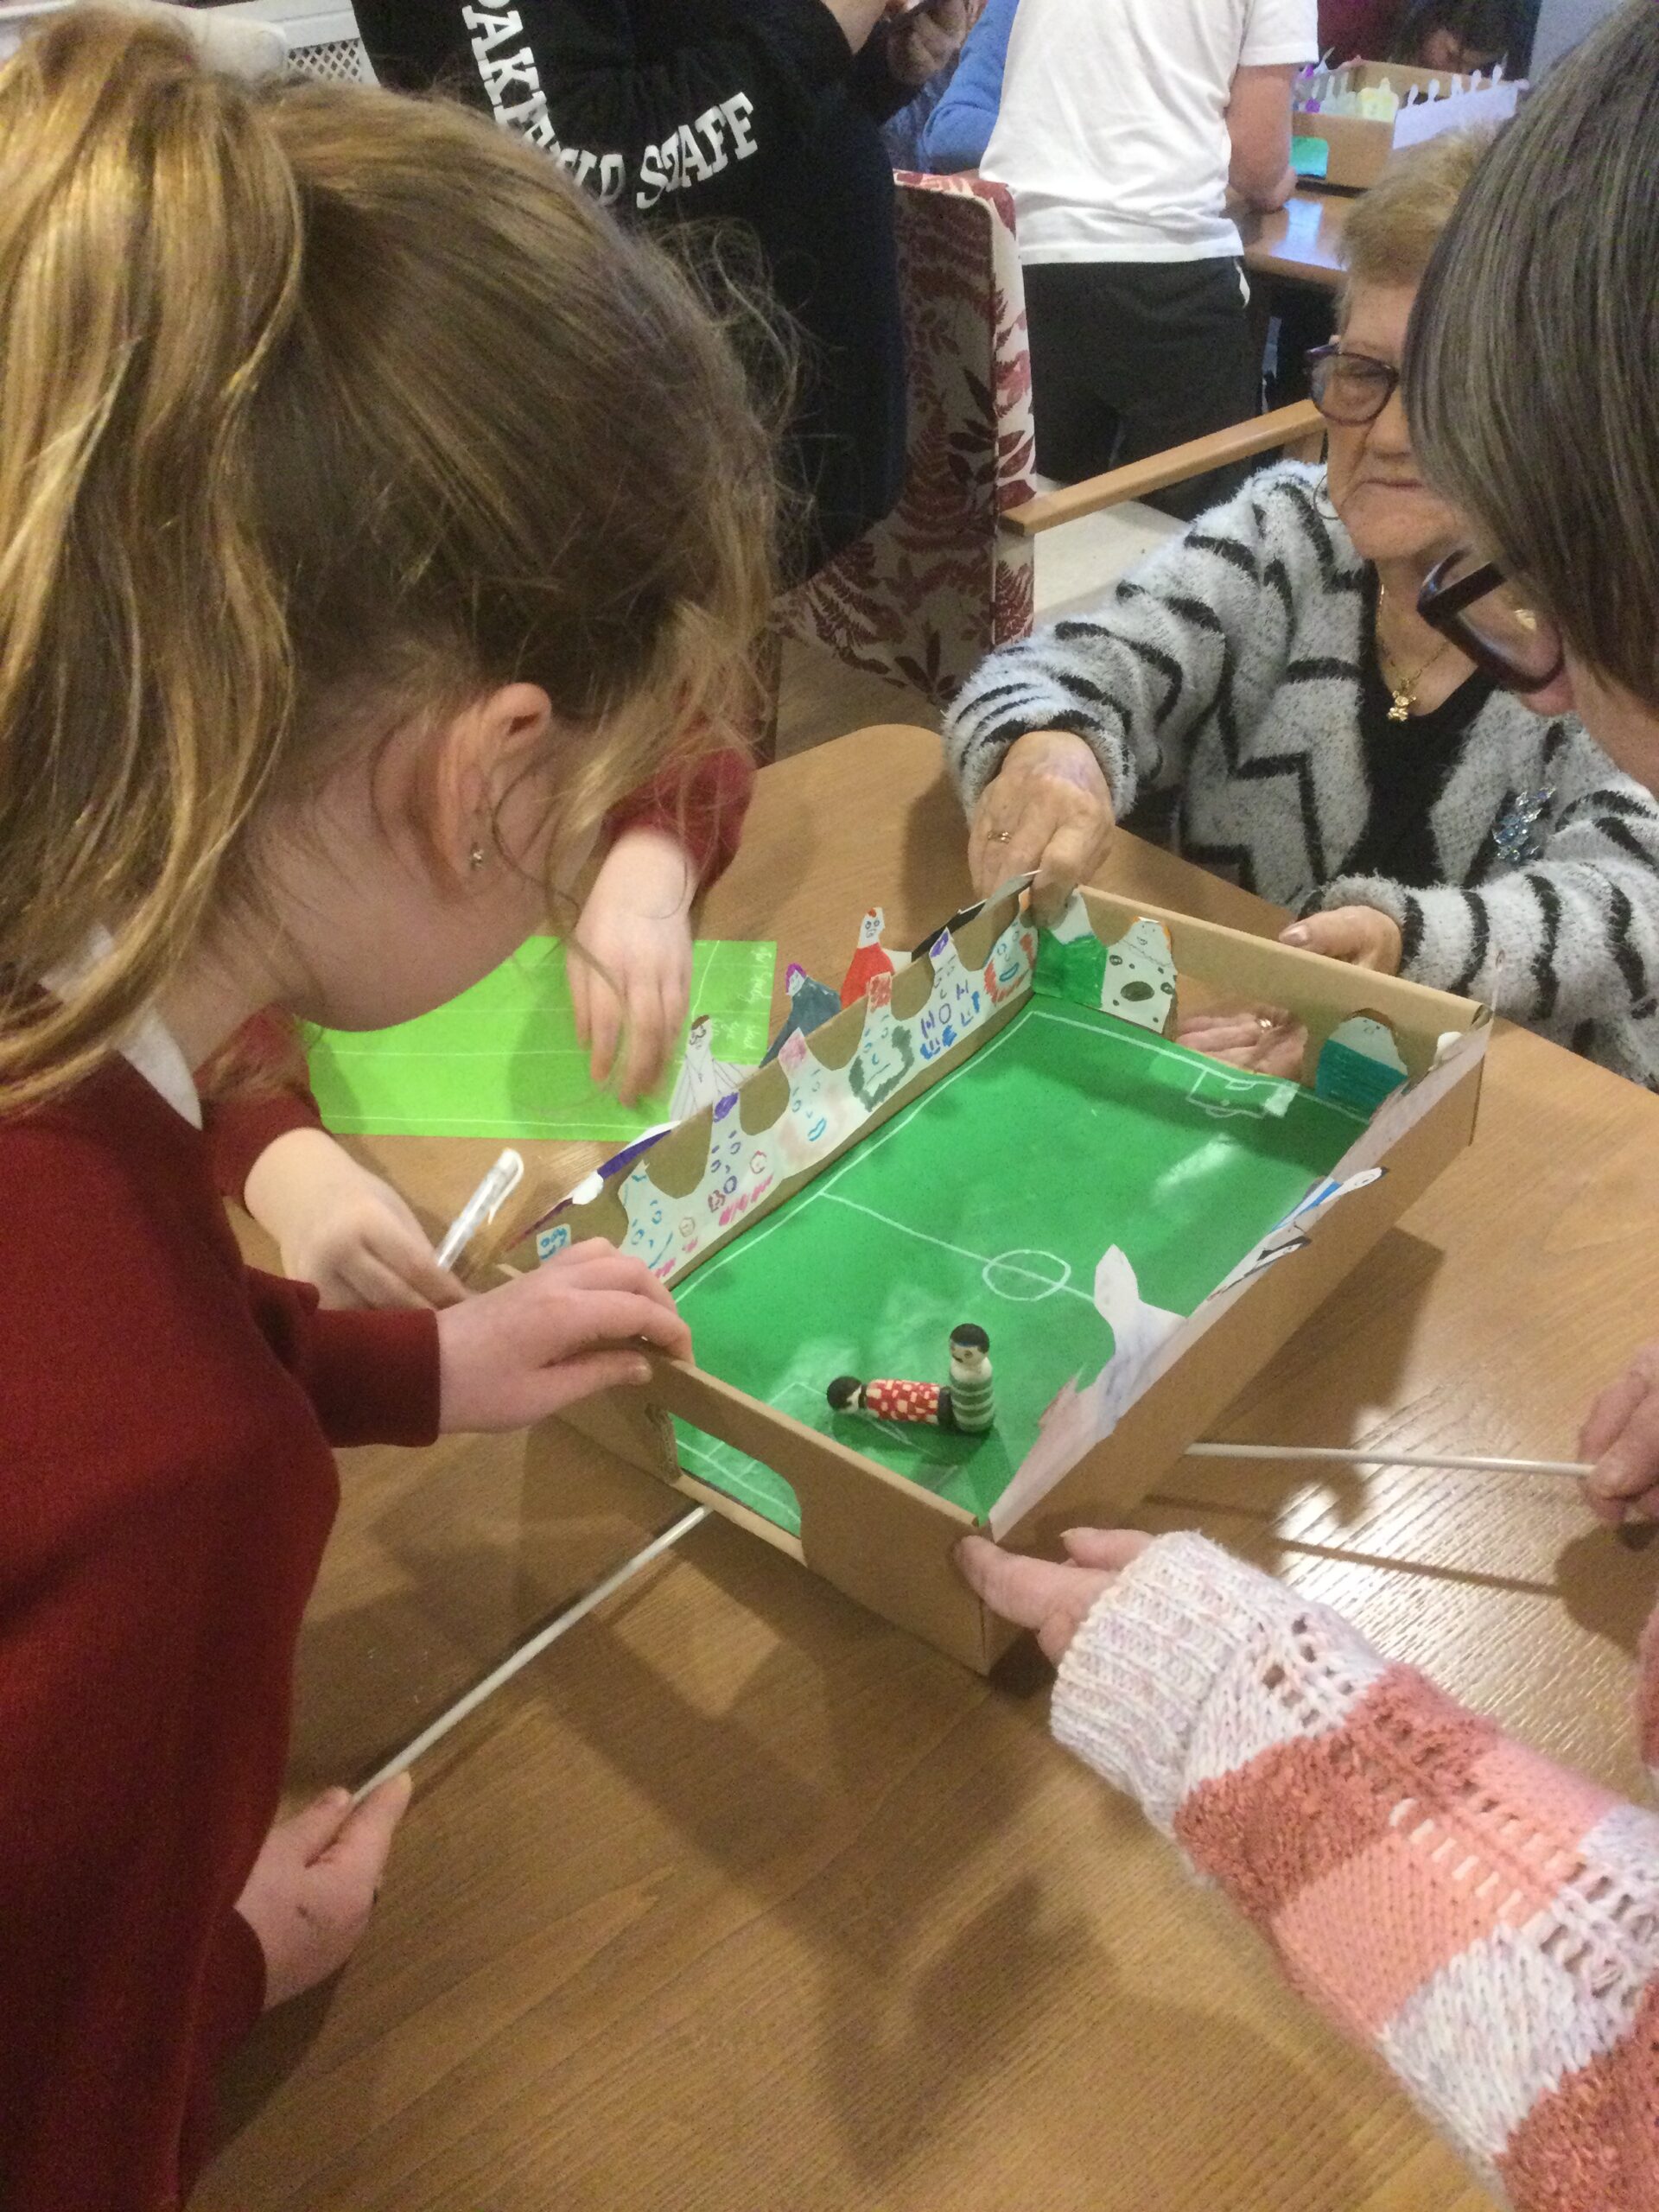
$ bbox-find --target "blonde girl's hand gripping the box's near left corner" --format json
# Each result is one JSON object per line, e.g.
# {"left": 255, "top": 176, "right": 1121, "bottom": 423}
{"left": 438, "top": 1236, "right": 690, "bottom": 1433}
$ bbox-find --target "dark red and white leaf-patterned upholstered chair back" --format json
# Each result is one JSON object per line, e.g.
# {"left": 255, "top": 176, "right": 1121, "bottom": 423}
{"left": 779, "top": 170, "right": 1033, "bottom": 706}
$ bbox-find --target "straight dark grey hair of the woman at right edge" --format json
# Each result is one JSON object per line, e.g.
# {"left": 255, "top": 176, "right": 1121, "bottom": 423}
{"left": 1405, "top": 0, "right": 1659, "bottom": 706}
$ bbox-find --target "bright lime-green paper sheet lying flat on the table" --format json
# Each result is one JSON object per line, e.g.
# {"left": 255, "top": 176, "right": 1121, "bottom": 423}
{"left": 309, "top": 938, "right": 777, "bottom": 1144}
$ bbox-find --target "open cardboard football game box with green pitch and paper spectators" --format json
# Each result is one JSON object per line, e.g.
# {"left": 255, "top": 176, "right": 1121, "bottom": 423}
{"left": 499, "top": 887, "right": 1489, "bottom": 1670}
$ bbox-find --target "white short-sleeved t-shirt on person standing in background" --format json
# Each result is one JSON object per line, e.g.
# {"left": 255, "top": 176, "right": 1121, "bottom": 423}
{"left": 980, "top": 0, "right": 1319, "bottom": 261}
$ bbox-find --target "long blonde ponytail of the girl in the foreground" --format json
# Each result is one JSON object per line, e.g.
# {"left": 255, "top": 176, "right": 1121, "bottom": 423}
{"left": 0, "top": 9, "right": 301, "bottom": 1103}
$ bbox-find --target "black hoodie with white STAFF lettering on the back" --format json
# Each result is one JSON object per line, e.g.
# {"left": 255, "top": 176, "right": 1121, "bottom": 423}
{"left": 356, "top": 0, "right": 912, "bottom": 573}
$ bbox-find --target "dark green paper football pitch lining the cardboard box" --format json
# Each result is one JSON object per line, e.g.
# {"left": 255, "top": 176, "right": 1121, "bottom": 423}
{"left": 675, "top": 1000, "right": 1365, "bottom": 1535}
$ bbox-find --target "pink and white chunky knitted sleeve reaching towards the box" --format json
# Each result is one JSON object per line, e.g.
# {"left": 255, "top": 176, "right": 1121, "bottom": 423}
{"left": 1053, "top": 1535, "right": 1659, "bottom": 2212}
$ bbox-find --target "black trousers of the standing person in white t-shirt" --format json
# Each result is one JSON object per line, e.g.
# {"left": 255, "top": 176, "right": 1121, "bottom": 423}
{"left": 1024, "top": 254, "right": 1261, "bottom": 520}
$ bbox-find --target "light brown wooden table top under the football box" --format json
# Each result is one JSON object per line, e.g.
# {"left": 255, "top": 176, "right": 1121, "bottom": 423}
{"left": 199, "top": 730, "right": 1659, "bottom": 2212}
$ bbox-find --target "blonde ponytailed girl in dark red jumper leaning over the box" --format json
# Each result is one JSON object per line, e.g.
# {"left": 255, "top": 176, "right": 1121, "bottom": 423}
{"left": 0, "top": 9, "right": 772, "bottom": 2212}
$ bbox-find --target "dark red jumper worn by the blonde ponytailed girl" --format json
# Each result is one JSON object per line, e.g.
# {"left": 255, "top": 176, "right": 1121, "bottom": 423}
{"left": 0, "top": 1059, "right": 438, "bottom": 2212}
